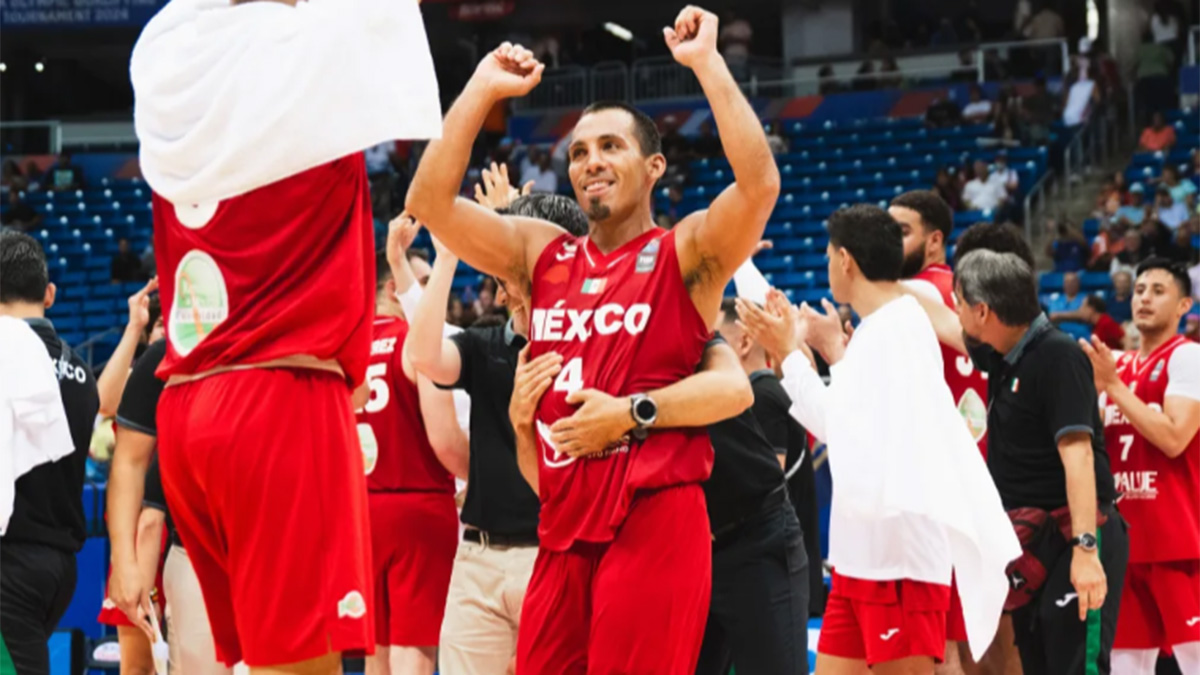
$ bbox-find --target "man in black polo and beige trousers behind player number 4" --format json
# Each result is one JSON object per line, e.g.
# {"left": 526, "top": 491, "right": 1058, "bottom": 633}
{"left": 407, "top": 190, "right": 587, "bottom": 675}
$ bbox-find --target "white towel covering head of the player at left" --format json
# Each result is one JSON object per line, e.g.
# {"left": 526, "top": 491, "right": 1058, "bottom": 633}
{"left": 130, "top": 0, "right": 442, "bottom": 204}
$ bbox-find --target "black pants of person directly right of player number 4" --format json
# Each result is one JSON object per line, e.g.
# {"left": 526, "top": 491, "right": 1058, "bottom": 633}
{"left": 696, "top": 500, "right": 809, "bottom": 675}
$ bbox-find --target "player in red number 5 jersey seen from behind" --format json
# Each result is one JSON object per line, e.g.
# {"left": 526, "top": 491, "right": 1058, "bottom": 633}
{"left": 358, "top": 221, "right": 468, "bottom": 675}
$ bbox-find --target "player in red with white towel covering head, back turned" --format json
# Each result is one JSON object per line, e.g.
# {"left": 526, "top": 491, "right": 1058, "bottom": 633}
{"left": 130, "top": 0, "right": 440, "bottom": 662}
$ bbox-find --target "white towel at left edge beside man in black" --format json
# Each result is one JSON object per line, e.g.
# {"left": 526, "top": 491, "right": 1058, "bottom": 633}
{"left": 0, "top": 316, "right": 74, "bottom": 534}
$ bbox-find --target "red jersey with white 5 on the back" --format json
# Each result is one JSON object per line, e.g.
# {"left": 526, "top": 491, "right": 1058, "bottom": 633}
{"left": 358, "top": 317, "right": 454, "bottom": 495}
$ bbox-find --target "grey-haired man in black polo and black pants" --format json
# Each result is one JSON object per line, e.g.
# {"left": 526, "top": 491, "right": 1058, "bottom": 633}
{"left": 924, "top": 250, "right": 1129, "bottom": 675}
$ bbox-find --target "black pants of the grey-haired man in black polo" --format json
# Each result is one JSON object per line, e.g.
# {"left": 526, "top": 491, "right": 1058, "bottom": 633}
{"left": 1013, "top": 507, "right": 1129, "bottom": 675}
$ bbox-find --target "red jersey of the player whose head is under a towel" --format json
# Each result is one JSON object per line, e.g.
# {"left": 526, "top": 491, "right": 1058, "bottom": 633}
{"left": 154, "top": 153, "right": 374, "bottom": 383}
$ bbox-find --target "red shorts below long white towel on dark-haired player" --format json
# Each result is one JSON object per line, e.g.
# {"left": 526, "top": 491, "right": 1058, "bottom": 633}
{"left": 817, "top": 572, "right": 950, "bottom": 667}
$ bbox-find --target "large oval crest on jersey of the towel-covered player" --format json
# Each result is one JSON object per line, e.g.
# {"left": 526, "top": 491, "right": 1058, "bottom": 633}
{"left": 167, "top": 249, "right": 229, "bottom": 357}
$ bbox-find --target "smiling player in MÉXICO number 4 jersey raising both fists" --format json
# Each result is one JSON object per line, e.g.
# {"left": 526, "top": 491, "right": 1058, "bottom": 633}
{"left": 407, "top": 7, "right": 779, "bottom": 674}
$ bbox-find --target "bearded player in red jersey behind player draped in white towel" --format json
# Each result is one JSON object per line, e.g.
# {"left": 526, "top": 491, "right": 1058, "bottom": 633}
{"left": 888, "top": 190, "right": 998, "bottom": 675}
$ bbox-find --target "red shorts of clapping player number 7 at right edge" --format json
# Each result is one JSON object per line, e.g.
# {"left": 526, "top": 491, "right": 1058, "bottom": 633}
{"left": 1112, "top": 560, "right": 1200, "bottom": 650}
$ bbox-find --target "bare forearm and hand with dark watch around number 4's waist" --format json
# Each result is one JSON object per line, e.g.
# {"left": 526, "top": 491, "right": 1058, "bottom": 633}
{"left": 551, "top": 345, "right": 754, "bottom": 456}
